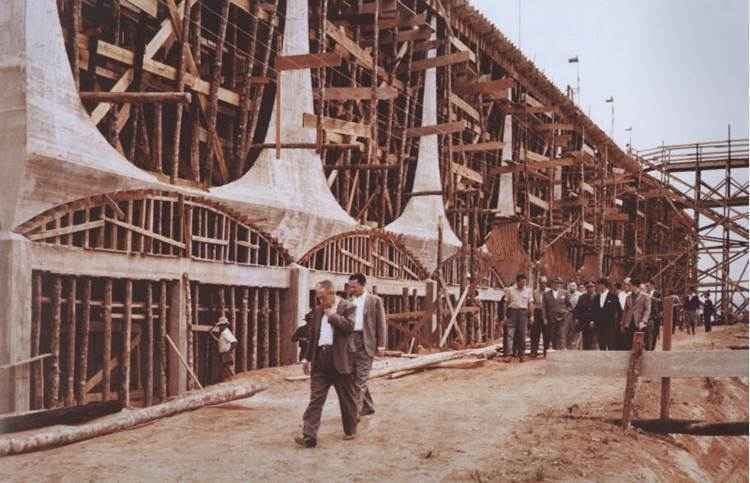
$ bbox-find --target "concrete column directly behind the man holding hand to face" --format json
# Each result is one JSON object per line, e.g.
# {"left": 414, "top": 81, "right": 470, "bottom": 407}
{"left": 281, "top": 265, "right": 310, "bottom": 364}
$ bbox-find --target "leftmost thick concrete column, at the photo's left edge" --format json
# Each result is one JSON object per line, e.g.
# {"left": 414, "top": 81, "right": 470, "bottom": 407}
{"left": 0, "top": 231, "right": 31, "bottom": 413}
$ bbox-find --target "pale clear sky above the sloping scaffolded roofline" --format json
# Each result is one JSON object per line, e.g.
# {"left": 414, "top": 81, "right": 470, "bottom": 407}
{"left": 471, "top": 0, "right": 749, "bottom": 149}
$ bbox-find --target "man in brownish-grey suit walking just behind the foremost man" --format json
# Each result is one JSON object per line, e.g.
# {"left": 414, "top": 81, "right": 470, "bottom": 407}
{"left": 349, "top": 273, "right": 388, "bottom": 416}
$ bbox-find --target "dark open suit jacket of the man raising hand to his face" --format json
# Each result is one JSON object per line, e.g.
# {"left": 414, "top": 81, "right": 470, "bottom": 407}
{"left": 305, "top": 300, "right": 355, "bottom": 374}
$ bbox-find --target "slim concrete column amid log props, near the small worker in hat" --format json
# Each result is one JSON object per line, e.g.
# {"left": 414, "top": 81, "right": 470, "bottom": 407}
{"left": 167, "top": 277, "right": 188, "bottom": 396}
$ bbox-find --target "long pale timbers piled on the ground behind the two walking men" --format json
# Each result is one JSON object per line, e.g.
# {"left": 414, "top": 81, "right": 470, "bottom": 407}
{"left": 286, "top": 344, "right": 502, "bottom": 381}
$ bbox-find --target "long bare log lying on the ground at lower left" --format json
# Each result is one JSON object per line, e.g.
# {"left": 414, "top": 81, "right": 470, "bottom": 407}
{"left": 0, "top": 381, "right": 267, "bottom": 456}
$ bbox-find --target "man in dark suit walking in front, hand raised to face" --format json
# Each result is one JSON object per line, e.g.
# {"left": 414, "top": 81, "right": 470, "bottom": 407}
{"left": 294, "top": 280, "right": 357, "bottom": 448}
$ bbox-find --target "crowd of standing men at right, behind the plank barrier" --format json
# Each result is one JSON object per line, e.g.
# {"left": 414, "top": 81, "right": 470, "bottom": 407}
{"left": 503, "top": 274, "right": 661, "bottom": 362}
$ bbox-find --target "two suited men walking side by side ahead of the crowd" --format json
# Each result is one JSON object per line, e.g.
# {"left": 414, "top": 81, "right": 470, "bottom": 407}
{"left": 294, "top": 273, "right": 387, "bottom": 448}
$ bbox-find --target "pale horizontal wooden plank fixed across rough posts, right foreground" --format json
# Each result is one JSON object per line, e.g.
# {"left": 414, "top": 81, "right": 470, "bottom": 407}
{"left": 547, "top": 350, "right": 748, "bottom": 377}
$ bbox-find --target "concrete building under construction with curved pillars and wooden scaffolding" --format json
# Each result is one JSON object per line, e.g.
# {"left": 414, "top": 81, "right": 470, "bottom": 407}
{"left": 0, "top": 0, "right": 747, "bottom": 412}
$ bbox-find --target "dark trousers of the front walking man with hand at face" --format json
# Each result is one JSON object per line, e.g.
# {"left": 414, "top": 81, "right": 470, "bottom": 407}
{"left": 302, "top": 346, "right": 357, "bottom": 439}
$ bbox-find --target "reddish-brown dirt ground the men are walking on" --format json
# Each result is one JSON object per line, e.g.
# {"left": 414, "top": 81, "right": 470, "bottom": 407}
{"left": 0, "top": 325, "right": 748, "bottom": 482}
